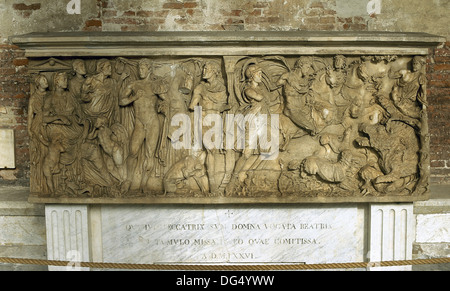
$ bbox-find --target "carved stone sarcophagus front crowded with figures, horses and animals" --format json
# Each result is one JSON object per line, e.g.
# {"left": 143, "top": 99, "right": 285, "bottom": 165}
{"left": 28, "top": 55, "right": 429, "bottom": 203}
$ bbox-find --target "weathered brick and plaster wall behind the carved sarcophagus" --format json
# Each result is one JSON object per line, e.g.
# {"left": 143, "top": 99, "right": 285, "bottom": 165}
{"left": 0, "top": 0, "right": 450, "bottom": 185}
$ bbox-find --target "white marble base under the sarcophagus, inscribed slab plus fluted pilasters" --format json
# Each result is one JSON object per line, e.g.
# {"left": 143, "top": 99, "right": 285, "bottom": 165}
{"left": 46, "top": 203, "right": 414, "bottom": 270}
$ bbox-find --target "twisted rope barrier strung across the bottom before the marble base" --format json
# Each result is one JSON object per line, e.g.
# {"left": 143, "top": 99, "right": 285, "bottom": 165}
{"left": 0, "top": 257, "right": 450, "bottom": 271}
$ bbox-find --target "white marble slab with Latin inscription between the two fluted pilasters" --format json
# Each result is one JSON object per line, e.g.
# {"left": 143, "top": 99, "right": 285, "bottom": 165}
{"left": 99, "top": 205, "right": 365, "bottom": 264}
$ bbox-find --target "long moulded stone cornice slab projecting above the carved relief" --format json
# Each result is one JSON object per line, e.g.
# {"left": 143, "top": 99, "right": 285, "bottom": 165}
{"left": 10, "top": 31, "right": 445, "bottom": 57}
